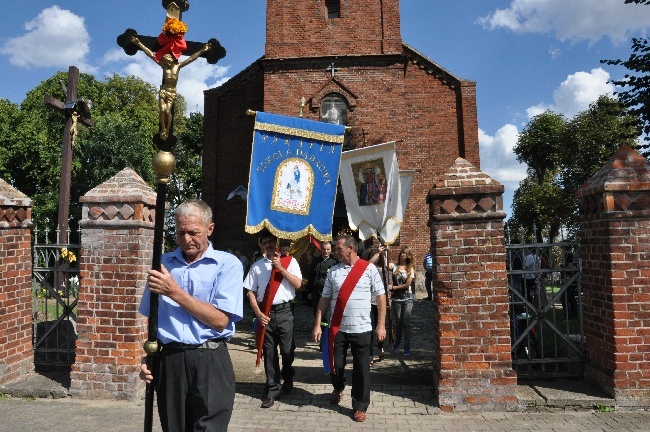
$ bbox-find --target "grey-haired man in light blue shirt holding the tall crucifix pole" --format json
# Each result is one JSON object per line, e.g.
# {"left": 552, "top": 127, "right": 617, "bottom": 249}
{"left": 139, "top": 200, "right": 244, "bottom": 432}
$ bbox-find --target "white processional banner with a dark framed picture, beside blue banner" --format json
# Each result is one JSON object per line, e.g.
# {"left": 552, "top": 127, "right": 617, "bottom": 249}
{"left": 340, "top": 141, "right": 413, "bottom": 244}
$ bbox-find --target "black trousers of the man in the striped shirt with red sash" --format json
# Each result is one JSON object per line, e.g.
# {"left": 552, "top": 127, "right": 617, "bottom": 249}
{"left": 330, "top": 331, "right": 372, "bottom": 412}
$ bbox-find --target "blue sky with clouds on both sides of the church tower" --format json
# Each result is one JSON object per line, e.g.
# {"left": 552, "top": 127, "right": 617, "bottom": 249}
{"left": 0, "top": 0, "right": 650, "bottom": 214}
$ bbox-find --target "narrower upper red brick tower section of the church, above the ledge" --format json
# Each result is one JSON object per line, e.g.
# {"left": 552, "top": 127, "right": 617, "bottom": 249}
{"left": 266, "top": 0, "right": 402, "bottom": 59}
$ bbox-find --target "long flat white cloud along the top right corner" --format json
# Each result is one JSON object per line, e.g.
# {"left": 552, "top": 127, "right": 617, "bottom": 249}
{"left": 478, "top": 0, "right": 650, "bottom": 44}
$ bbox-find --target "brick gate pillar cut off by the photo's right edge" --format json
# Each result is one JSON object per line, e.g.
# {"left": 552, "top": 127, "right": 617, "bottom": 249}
{"left": 576, "top": 146, "right": 650, "bottom": 407}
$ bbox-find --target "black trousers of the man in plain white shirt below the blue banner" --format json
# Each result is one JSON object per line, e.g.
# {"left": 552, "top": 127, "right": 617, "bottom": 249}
{"left": 263, "top": 303, "right": 296, "bottom": 398}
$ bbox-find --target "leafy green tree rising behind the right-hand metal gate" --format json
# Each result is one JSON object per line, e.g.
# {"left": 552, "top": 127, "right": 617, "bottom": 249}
{"left": 512, "top": 96, "right": 639, "bottom": 242}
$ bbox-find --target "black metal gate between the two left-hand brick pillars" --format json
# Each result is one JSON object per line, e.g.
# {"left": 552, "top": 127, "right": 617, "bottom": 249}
{"left": 32, "top": 228, "right": 80, "bottom": 368}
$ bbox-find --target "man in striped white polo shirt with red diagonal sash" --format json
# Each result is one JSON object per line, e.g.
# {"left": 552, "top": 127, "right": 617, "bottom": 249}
{"left": 313, "top": 235, "right": 386, "bottom": 422}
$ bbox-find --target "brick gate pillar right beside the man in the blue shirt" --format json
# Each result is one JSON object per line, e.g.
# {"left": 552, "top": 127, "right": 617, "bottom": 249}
{"left": 70, "top": 168, "right": 156, "bottom": 400}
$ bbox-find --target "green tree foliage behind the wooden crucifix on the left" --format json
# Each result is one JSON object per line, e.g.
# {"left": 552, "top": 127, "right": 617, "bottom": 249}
{"left": 0, "top": 72, "right": 203, "bottom": 241}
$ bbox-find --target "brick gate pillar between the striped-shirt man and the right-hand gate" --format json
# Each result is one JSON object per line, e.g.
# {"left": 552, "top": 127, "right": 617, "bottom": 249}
{"left": 427, "top": 158, "right": 517, "bottom": 411}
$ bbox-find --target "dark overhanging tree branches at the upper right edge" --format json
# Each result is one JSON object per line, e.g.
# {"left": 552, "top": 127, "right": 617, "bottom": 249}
{"left": 601, "top": 0, "right": 650, "bottom": 157}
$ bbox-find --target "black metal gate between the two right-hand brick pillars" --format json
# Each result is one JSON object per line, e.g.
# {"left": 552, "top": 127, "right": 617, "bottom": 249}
{"left": 506, "top": 242, "right": 585, "bottom": 378}
